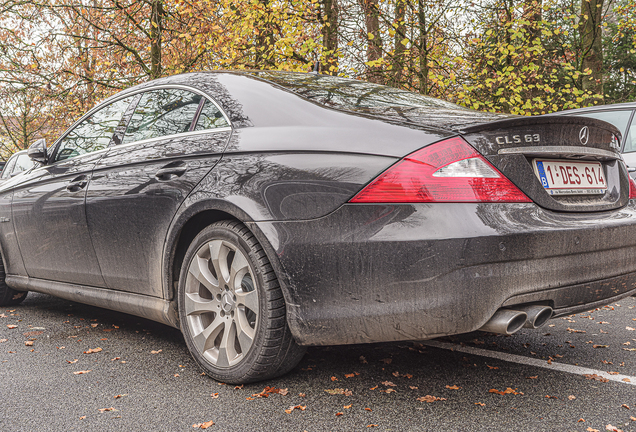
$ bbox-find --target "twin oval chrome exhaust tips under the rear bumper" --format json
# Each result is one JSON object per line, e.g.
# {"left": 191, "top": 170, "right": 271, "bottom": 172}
{"left": 479, "top": 305, "right": 552, "bottom": 335}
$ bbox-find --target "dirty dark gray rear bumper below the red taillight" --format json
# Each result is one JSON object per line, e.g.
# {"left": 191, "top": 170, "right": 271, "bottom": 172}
{"left": 256, "top": 204, "right": 636, "bottom": 345}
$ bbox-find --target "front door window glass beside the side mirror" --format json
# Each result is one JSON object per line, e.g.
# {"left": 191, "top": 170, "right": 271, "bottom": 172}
{"left": 55, "top": 96, "right": 133, "bottom": 161}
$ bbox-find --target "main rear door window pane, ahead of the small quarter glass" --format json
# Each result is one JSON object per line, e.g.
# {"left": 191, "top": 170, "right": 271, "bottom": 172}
{"left": 123, "top": 89, "right": 201, "bottom": 144}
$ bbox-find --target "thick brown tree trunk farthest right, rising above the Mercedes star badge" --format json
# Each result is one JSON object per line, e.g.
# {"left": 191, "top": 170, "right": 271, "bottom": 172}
{"left": 579, "top": 0, "right": 603, "bottom": 98}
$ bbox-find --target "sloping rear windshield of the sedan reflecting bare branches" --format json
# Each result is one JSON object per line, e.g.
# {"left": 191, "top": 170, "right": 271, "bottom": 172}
{"left": 248, "top": 71, "right": 467, "bottom": 111}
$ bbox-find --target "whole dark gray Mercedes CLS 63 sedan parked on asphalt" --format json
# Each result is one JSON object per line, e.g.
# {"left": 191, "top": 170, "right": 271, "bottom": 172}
{"left": 0, "top": 72, "right": 636, "bottom": 383}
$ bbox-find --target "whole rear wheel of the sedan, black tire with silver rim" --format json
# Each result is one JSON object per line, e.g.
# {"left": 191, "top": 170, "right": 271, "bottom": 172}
{"left": 178, "top": 221, "right": 305, "bottom": 384}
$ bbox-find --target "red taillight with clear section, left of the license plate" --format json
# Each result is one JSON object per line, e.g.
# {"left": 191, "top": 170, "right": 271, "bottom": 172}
{"left": 349, "top": 137, "right": 532, "bottom": 203}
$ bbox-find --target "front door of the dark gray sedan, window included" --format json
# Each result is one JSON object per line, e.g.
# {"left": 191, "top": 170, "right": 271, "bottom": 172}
{"left": 11, "top": 98, "right": 132, "bottom": 287}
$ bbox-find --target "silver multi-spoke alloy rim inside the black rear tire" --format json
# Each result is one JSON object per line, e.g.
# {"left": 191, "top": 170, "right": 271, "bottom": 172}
{"left": 184, "top": 240, "right": 259, "bottom": 368}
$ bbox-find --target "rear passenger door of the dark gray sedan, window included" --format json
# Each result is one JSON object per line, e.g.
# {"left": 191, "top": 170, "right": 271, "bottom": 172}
{"left": 86, "top": 88, "right": 232, "bottom": 297}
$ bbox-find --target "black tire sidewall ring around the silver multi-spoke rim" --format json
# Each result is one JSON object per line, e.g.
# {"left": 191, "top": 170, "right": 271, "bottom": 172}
{"left": 177, "top": 223, "right": 269, "bottom": 383}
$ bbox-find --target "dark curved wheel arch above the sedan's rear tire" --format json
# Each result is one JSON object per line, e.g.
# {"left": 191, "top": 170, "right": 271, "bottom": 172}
{"left": 162, "top": 200, "right": 294, "bottom": 329}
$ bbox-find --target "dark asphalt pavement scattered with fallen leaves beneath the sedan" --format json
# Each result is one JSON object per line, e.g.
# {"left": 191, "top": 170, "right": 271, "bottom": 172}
{"left": 0, "top": 293, "right": 636, "bottom": 432}
